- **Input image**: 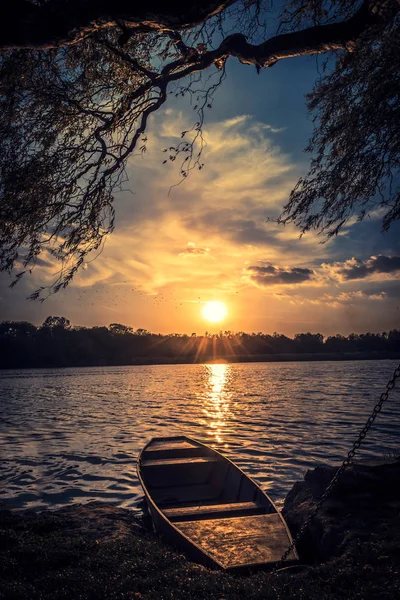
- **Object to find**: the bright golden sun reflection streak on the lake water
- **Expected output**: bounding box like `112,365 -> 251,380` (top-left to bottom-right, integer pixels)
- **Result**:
203,364 -> 231,446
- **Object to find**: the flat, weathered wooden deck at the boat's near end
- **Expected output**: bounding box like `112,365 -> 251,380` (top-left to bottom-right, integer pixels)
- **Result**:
174,513 -> 297,569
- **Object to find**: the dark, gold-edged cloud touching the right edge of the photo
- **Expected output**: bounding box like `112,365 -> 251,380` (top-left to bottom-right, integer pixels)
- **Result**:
321,254 -> 400,281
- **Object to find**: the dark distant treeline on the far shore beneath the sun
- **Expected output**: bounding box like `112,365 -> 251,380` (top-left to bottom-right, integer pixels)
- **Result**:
0,317 -> 400,368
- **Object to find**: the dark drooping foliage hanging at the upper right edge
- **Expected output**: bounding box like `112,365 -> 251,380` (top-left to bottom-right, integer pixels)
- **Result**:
281,7 -> 400,236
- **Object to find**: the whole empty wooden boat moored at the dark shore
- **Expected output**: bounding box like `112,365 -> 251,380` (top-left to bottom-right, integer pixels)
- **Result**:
137,436 -> 298,569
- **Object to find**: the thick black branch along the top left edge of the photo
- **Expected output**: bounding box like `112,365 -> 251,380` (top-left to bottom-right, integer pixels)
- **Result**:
0,0 -> 234,49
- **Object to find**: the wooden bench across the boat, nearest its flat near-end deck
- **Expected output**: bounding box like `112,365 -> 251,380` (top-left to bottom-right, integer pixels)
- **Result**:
163,502 -> 269,521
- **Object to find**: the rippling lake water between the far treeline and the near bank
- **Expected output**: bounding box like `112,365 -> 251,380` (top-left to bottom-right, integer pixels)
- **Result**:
0,360 -> 400,511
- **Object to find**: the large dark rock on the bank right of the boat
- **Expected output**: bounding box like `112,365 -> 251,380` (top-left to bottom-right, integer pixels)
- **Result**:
283,460 -> 400,563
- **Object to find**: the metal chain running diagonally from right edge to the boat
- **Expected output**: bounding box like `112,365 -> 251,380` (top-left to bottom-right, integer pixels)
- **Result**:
274,364 -> 400,572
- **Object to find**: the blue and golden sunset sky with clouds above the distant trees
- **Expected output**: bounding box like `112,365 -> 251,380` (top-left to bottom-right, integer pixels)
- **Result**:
0,52 -> 400,336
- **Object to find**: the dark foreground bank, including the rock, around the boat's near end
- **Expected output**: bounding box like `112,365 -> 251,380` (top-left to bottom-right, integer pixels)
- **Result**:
0,460 -> 400,600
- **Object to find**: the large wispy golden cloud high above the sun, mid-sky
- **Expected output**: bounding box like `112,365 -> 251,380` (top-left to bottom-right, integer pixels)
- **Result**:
113,109 -> 300,247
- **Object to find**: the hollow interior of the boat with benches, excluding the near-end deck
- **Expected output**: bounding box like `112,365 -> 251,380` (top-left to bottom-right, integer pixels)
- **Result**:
140,437 -> 276,521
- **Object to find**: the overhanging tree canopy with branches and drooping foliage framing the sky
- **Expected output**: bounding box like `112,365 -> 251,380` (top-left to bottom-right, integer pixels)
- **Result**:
0,0 -> 400,298
